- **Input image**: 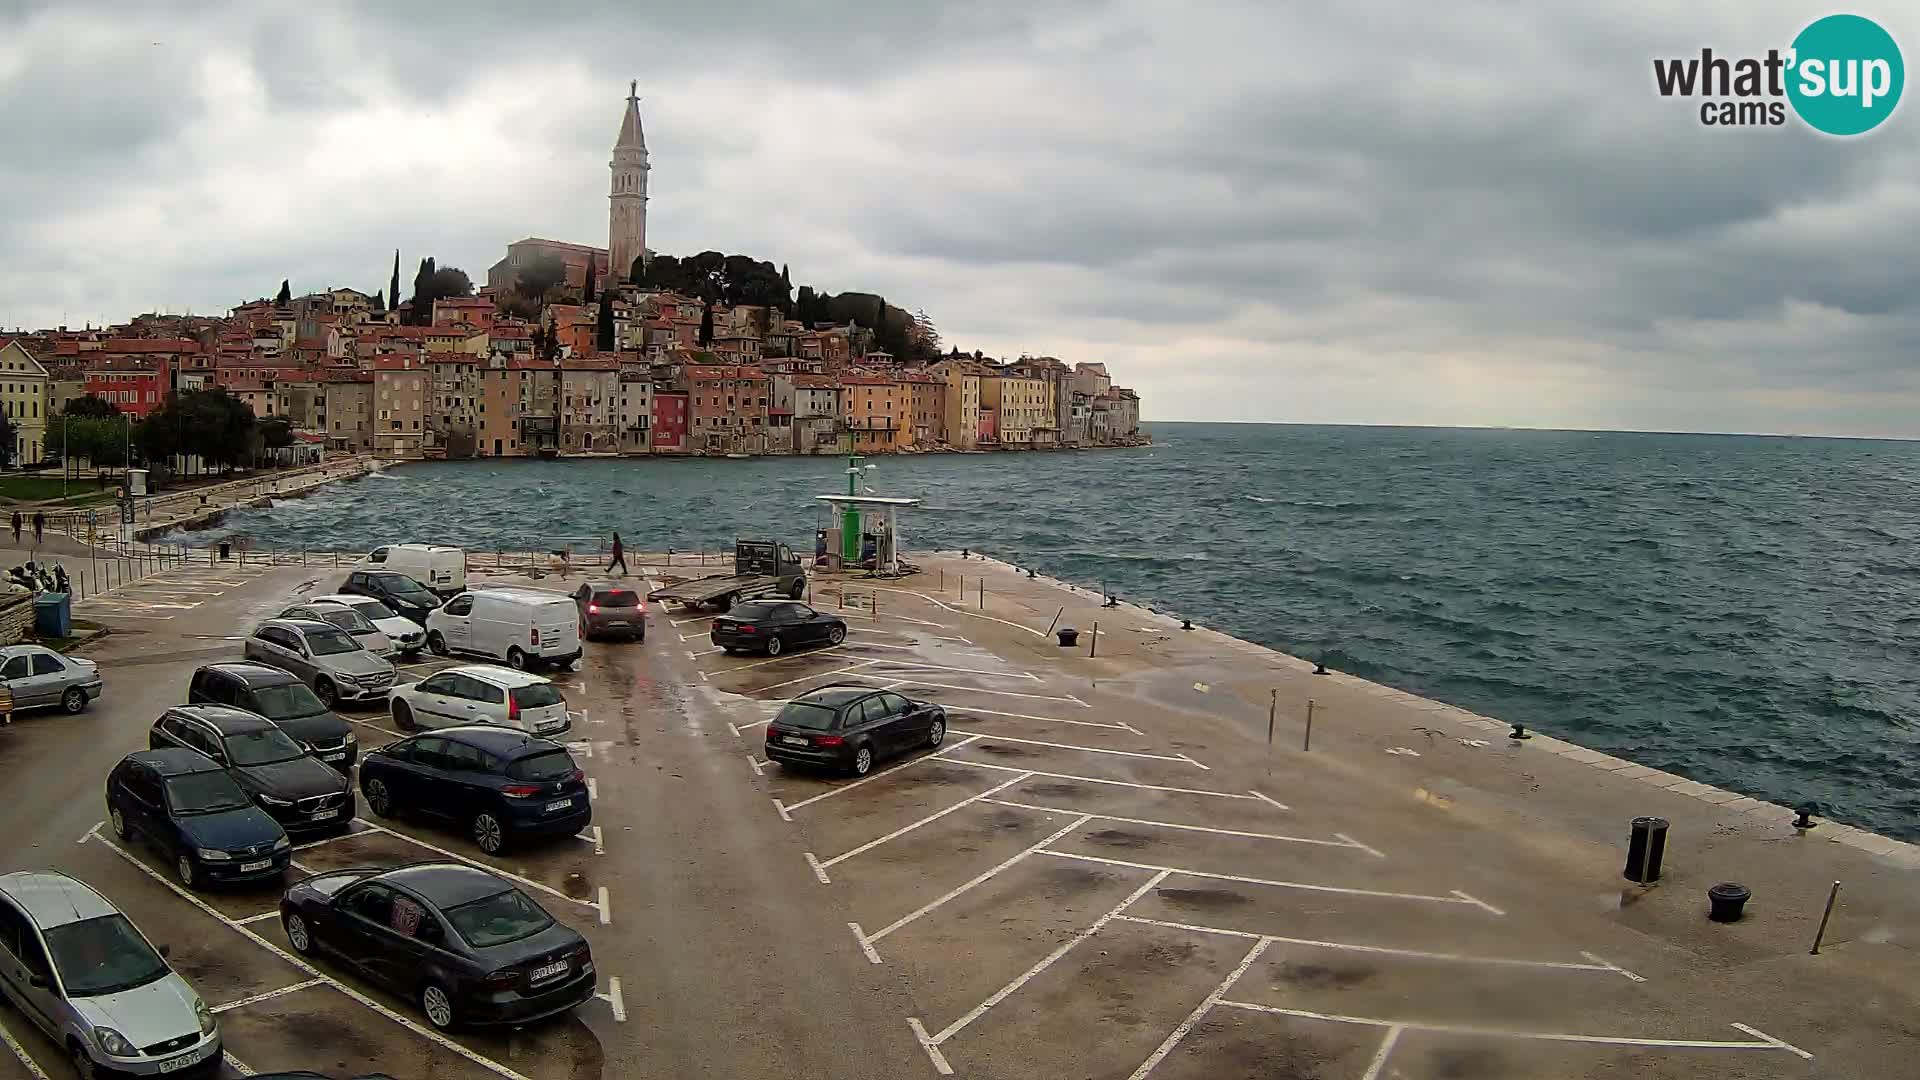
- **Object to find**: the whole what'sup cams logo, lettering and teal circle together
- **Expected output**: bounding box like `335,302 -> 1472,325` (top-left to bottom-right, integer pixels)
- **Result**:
1653,15 -> 1907,135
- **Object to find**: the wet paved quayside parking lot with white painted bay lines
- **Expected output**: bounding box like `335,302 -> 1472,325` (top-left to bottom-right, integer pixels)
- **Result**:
0,552 -> 1920,1080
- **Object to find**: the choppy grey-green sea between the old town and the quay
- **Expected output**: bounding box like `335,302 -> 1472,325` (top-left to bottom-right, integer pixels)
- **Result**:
188,423 -> 1920,840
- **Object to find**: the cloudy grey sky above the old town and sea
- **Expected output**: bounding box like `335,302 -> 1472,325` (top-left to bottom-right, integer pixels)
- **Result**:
0,0 -> 1920,438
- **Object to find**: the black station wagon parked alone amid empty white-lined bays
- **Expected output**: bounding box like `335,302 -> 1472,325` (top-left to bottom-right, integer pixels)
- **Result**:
766,684 -> 947,776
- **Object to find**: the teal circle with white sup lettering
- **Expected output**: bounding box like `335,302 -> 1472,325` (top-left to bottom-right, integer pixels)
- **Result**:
1788,15 -> 1907,135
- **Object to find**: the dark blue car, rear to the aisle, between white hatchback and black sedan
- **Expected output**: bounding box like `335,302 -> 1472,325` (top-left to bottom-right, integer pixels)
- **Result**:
361,724 -> 593,855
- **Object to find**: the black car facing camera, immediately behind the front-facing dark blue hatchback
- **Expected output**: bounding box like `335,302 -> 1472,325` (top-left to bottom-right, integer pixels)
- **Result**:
146,705 -> 355,836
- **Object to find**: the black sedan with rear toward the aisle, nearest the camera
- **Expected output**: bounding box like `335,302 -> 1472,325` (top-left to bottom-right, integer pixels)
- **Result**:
280,863 -> 595,1030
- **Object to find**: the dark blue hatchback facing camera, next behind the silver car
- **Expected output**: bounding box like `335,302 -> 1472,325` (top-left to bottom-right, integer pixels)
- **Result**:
108,746 -> 292,888
